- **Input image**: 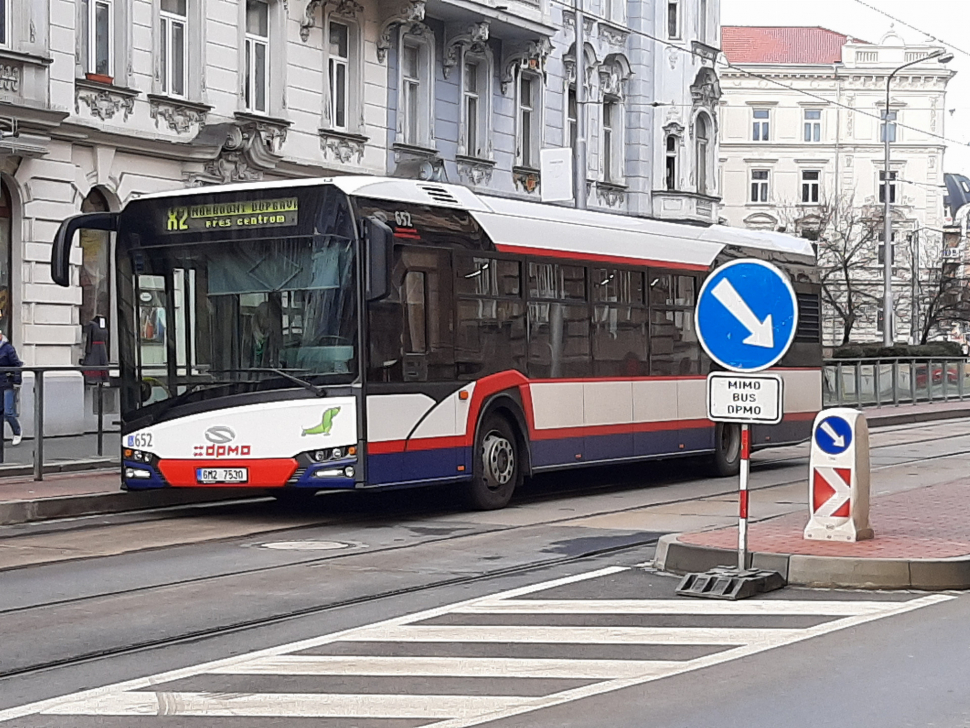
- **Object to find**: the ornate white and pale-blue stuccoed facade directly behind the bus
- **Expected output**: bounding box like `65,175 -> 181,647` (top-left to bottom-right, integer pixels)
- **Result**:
0,0 -> 720,434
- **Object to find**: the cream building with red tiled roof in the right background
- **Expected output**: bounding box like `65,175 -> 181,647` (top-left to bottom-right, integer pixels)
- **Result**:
720,27 -> 953,344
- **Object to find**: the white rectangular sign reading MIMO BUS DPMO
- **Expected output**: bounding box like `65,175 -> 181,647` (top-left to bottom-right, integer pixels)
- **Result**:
707,372 -> 785,425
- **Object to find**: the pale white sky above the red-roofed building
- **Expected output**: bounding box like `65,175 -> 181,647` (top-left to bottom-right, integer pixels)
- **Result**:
721,0 -> 970,176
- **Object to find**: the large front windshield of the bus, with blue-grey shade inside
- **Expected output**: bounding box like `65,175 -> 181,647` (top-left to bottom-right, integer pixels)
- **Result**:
118,188 -> 358,415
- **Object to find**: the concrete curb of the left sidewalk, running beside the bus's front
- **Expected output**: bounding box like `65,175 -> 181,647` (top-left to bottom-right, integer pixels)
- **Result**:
0,488 -> 266,526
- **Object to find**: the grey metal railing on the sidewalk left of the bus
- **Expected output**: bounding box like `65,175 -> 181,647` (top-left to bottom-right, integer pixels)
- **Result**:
0,364 -> 119,480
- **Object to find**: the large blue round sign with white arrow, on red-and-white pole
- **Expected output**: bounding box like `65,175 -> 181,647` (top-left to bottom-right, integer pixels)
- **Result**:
697,259 -> 798,372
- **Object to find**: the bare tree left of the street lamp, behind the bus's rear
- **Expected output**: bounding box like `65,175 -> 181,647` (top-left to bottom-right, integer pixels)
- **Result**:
778,195 -> 882,345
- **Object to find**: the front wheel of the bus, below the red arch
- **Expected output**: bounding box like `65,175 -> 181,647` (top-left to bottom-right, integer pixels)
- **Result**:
466,414 -> 522,511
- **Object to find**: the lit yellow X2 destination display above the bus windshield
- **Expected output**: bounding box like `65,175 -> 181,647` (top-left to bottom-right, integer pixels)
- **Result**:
165,197 -> 299,233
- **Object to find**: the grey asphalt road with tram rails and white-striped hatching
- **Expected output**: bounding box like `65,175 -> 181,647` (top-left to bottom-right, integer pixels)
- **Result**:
0,421 -> 970,728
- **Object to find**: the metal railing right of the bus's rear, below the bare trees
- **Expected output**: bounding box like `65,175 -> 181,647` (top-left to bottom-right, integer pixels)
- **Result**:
822,357 -> 970,407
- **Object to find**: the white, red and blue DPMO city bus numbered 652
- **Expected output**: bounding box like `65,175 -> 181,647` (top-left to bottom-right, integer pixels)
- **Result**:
51,176 -> 822,509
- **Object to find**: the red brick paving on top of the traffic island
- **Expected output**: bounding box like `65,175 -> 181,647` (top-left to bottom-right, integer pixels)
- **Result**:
679,478 -> 970,560
